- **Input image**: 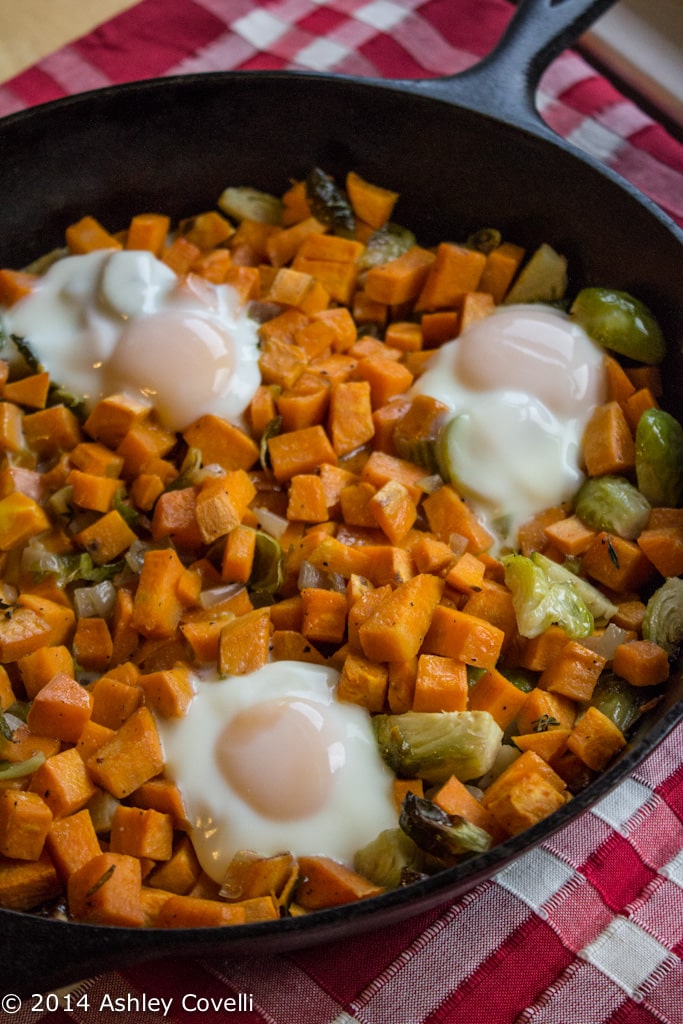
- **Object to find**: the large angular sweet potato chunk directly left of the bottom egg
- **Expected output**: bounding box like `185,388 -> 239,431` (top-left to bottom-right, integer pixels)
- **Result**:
86,706 -> 164,800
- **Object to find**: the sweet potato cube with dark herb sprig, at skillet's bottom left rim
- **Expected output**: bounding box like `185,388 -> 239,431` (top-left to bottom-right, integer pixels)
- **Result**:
67,852 -> 144,928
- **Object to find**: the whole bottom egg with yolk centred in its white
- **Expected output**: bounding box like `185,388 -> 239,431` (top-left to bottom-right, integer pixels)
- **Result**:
159,662 -> 397,882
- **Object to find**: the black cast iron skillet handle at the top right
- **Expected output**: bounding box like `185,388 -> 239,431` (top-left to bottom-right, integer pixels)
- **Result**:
413,0 -> 615,131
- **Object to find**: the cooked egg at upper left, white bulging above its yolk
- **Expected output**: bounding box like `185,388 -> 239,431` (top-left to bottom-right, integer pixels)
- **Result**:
5,250 -> 260,431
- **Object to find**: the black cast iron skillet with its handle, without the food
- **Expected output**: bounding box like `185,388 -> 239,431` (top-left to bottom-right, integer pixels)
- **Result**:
0,0 -> 683,994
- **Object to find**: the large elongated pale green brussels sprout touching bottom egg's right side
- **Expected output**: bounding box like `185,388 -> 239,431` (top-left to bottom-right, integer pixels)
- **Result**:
372,711 -> 503,782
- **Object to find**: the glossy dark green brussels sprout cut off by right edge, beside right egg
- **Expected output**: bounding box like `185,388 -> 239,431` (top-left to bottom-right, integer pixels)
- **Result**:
636,409 -> 683,508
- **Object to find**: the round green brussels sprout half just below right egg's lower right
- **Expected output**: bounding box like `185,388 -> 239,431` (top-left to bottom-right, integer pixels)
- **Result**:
574,475 -> 650,541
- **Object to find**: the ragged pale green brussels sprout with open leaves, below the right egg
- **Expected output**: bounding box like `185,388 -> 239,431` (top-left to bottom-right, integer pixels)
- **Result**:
503,555 -> 594,639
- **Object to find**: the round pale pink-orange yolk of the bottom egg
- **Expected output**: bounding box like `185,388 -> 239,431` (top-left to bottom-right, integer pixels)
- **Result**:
215,700 -> 343,820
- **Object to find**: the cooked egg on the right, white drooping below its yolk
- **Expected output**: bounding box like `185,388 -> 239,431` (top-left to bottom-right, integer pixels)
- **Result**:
414,304 -> 606,548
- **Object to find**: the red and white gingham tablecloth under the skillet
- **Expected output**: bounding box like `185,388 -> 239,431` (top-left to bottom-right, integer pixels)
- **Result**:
0,0 -> 683,1024
